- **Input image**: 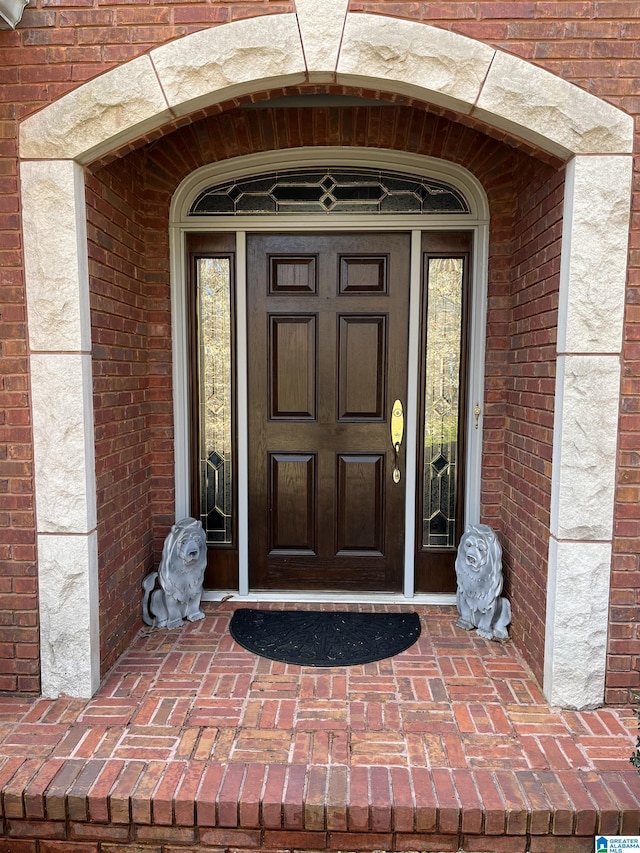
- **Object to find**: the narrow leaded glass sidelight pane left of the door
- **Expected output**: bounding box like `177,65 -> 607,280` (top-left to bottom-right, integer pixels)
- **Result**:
196,257 -> 233,545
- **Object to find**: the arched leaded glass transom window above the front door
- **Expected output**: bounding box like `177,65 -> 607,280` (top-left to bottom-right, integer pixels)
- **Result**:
189,169 -> 470,216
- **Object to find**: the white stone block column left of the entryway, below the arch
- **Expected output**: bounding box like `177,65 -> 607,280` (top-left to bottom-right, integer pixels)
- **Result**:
20,160 -> 100,697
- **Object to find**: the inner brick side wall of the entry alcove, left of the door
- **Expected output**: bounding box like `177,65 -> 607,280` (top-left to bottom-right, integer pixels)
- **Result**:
87,155 -> 152,673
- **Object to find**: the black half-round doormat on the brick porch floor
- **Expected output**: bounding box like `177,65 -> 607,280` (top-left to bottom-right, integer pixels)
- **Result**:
229,609 -> 420,666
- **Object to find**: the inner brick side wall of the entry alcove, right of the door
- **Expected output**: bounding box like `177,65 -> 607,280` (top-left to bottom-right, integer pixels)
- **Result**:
502,158 -> 564,680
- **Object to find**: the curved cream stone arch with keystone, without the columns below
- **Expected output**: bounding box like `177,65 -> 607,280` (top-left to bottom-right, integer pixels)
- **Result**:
20,0 -> 633,163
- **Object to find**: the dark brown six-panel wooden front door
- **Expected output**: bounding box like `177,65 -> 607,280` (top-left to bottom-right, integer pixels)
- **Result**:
247,234 -> 410,591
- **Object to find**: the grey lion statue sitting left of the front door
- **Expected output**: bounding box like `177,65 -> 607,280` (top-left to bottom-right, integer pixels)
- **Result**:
142,518 -> 207,628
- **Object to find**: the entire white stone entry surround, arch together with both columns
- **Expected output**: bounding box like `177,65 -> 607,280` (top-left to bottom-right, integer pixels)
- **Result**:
20,5 -> 633,707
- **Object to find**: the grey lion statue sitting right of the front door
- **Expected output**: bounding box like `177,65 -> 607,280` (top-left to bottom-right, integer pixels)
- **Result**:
455,524 -> 511,640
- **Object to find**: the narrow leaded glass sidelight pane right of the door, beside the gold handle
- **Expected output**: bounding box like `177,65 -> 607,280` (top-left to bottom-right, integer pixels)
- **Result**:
422,257 -> 464,548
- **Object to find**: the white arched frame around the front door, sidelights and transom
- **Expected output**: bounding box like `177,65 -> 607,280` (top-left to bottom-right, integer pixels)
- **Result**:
170,147 -> 489,604
